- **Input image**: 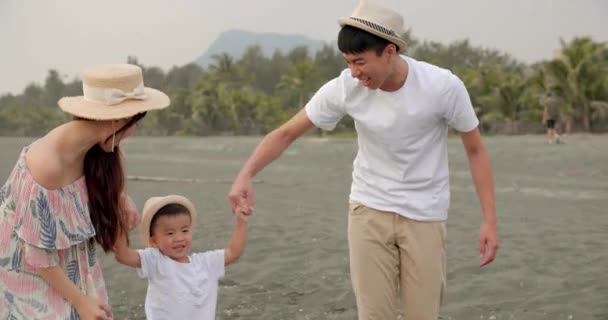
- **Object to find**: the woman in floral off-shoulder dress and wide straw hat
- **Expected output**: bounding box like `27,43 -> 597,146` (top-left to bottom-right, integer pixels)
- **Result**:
0,65 -> 169,320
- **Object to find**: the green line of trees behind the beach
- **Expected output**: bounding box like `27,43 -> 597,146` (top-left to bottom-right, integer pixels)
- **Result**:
0,33 -> 608,136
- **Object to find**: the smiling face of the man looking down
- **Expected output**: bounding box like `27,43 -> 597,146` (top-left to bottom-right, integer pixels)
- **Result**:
342,46 -> 392,90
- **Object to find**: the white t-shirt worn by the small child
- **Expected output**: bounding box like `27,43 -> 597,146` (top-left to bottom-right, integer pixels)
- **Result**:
137,248 -> 224,320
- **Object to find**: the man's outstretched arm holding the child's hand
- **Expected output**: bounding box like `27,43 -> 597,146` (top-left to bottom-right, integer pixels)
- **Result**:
228,109 -> 314,214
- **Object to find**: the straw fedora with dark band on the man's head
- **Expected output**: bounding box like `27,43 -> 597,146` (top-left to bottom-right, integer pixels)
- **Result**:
338,0 -> 407,52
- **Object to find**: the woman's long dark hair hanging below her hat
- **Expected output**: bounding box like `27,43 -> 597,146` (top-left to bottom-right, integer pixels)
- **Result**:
84,112 -> 146,252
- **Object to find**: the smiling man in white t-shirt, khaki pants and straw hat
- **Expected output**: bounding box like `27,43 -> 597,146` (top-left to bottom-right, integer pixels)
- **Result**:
229,2 -> 498,320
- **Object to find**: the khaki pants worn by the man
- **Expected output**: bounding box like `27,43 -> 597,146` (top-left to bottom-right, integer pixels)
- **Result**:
348,203 -> 446,320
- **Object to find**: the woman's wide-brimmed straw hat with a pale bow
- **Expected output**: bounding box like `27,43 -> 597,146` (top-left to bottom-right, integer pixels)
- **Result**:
59,64 -> 170,120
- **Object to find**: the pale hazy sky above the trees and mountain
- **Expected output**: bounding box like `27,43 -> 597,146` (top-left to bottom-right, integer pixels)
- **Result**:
0,0 -> 608,94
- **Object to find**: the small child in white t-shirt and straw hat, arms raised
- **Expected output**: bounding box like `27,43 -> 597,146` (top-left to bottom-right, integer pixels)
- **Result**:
114,195 -> 247,320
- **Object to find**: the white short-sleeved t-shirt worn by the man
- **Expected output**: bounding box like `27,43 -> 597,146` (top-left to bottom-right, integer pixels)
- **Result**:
305,56 -> 479,221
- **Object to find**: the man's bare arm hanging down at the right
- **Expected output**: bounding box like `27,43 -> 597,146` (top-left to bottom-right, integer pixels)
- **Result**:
460,129 -> 498,266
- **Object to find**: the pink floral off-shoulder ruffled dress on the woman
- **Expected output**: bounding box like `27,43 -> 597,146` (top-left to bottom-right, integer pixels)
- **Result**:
0,147 -> 108,320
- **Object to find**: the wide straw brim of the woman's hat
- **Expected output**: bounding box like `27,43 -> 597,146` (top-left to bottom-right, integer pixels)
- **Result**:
58,88 -> 171,120
